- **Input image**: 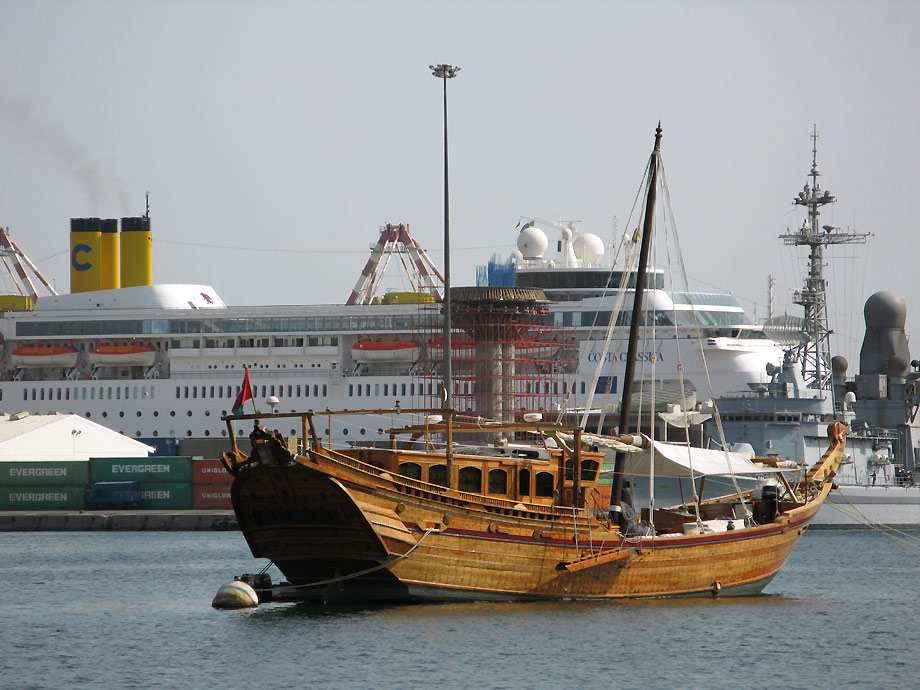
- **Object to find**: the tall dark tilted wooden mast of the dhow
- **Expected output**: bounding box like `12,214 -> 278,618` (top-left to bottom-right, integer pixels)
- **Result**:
610,122 -> 661,524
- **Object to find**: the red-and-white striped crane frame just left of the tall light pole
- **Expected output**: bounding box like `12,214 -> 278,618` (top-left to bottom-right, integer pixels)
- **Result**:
345,223 -> 444,306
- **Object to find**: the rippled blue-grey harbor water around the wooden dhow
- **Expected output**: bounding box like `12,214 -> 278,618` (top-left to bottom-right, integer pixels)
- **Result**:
0,531 -> 920,689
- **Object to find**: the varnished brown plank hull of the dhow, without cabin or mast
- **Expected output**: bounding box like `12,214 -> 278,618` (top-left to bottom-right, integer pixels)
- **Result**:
233,436 -> 842,601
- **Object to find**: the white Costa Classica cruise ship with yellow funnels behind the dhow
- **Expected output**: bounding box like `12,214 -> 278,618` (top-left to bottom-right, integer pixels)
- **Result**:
0,214 -> 783,456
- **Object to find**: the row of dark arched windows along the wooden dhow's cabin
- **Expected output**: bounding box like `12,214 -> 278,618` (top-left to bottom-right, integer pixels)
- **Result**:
399,460 -> 599,498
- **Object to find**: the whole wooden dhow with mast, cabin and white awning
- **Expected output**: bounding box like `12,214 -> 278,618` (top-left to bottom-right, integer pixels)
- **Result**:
223,127 -> 845,602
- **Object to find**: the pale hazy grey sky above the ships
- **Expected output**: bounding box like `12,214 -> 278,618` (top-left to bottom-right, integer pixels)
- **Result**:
0,0 -> 920,366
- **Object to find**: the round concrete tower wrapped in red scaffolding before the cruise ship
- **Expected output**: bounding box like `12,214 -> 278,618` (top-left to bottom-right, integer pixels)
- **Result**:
417,287 -> 575,422
